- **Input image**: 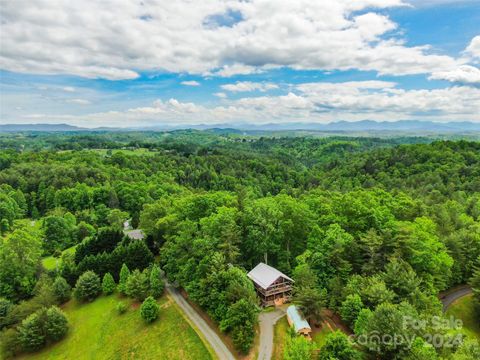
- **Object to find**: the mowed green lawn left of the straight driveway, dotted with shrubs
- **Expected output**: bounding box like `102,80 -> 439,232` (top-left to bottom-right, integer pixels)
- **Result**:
19,295 -> 212,360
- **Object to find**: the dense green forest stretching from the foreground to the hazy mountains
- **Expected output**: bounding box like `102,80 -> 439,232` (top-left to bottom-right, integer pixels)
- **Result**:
0,130 -> 480,360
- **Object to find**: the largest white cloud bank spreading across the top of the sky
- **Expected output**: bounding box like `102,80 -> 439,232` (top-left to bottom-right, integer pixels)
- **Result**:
0,0 -> 466,80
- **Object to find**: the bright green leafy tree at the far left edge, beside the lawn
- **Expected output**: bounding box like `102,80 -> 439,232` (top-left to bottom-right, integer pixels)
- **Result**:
0,229 -> 42,301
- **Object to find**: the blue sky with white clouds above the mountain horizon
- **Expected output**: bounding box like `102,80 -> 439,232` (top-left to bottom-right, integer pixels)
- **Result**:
0,0 -> 480,127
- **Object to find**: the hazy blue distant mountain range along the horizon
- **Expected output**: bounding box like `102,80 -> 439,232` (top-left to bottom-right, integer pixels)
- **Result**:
0,120 -> 480,133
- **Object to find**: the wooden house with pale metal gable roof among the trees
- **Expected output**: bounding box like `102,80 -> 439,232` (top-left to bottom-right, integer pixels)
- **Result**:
247,263 -> 294,306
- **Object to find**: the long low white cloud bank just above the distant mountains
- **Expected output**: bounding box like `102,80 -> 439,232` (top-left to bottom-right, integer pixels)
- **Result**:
11,81 -> 480,126
